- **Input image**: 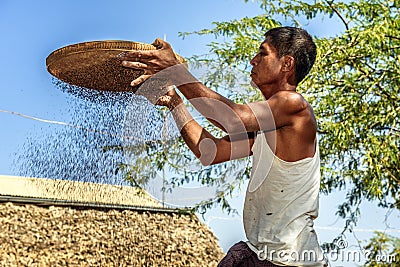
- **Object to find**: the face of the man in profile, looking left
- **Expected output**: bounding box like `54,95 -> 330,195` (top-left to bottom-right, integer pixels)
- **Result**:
250,38 -> 283,90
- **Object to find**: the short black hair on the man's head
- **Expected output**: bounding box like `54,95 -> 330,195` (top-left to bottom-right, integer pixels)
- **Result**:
265,26 -> 317,84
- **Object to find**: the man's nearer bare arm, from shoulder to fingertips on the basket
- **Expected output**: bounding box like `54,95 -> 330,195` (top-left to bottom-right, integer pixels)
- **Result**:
123,39 -> 306,135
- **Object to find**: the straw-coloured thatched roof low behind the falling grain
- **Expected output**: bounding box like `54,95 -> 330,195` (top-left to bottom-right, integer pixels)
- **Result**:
0,176 -> 223,266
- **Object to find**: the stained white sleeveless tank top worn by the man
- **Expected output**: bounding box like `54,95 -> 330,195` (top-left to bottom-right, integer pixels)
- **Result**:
243,132 -> 326,266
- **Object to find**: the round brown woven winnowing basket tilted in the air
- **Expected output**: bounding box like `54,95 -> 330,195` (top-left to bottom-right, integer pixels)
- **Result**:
46,40 -> 184,92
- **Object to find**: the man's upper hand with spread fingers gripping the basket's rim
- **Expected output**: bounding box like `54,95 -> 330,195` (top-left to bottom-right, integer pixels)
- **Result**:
122,38 -> 180,86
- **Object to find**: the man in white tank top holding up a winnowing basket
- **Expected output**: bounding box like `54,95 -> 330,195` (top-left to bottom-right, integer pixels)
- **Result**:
123,27 -> 326,266
